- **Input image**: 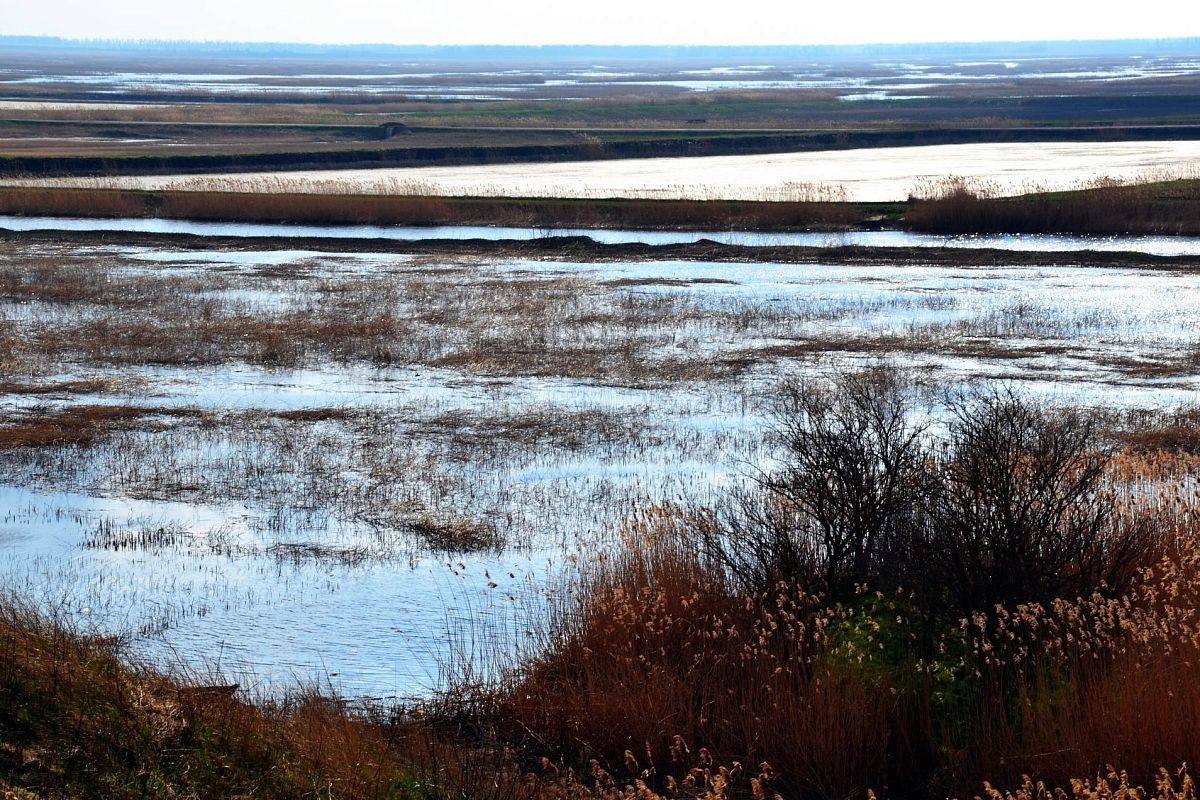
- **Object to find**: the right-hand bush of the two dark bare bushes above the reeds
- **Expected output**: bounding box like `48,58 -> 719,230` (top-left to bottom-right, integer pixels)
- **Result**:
910,391 -> 1138,613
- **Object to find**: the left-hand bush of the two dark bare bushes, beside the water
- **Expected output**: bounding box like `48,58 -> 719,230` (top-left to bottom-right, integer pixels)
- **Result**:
706,367 -> 925,590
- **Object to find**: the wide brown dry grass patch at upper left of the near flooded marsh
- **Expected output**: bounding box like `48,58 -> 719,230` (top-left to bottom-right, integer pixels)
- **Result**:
6,248 -> 768,384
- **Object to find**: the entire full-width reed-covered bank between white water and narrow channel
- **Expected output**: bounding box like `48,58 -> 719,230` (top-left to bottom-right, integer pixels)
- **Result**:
0,178 -> 1200,235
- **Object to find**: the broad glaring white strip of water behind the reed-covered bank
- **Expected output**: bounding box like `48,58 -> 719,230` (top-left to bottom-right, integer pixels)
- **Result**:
5,142 -> 1200,203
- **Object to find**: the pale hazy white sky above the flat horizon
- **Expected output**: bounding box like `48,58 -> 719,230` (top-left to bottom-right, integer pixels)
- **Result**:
0,0 -> 1200,44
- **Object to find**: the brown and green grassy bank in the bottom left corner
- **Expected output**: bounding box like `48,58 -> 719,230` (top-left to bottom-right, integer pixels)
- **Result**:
0,599 -> 427,799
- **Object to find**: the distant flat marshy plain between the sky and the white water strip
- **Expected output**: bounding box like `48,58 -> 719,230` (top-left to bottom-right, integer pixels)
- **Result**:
0,37 -> 1200,175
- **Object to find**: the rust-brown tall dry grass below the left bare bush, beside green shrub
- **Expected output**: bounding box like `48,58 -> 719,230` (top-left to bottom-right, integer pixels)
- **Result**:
496,505 -> 914,798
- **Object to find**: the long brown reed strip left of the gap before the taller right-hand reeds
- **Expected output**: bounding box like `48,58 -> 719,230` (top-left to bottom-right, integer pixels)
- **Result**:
0,183 -> 866,230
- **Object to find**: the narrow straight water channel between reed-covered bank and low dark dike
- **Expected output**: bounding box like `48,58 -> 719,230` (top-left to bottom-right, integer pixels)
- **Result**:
7,216 -> 1200,255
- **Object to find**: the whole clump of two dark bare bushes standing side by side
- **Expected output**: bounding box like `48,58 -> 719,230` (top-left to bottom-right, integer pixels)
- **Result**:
695,367 -> 1159,614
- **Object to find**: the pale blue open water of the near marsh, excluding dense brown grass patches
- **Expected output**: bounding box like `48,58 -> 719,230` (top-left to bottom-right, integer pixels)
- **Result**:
0,245 -> 1200,698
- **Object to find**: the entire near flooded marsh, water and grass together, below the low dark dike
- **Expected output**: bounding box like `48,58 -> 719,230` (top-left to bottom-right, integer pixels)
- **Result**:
0,235 -> 1200,699
